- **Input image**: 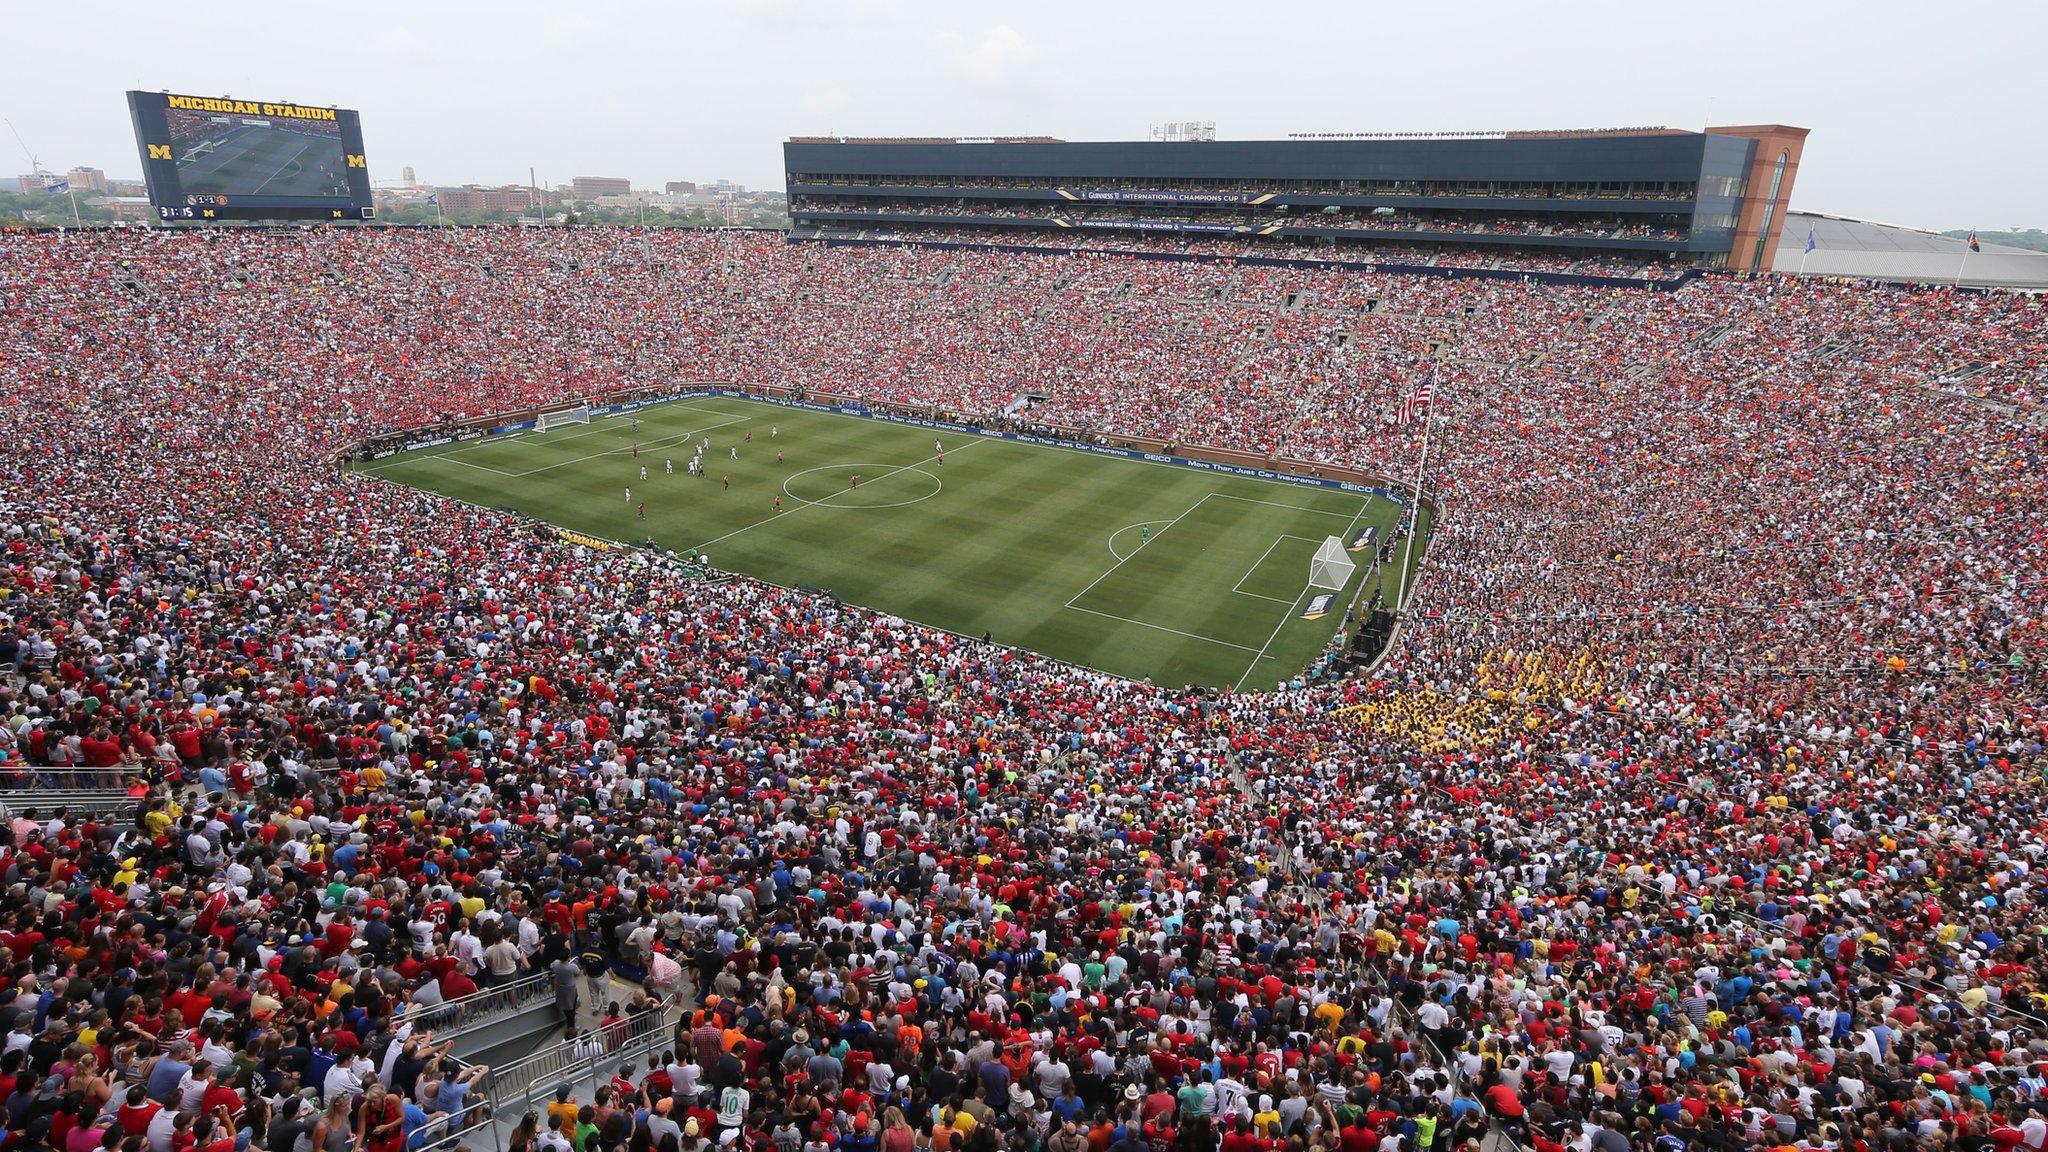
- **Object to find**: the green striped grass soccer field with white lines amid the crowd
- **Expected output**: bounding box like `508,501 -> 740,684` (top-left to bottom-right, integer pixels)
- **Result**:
362,398 -> 1427,689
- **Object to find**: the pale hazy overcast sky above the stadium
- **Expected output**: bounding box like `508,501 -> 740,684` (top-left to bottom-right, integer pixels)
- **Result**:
0,0 -> 2048,230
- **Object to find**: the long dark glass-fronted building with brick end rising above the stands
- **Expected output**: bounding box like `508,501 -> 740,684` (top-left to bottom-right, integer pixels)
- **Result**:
782,125 -> 1806,273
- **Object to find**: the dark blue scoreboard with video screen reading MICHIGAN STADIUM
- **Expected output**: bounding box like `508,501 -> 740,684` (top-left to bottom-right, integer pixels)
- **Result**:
129,92 -> 375,221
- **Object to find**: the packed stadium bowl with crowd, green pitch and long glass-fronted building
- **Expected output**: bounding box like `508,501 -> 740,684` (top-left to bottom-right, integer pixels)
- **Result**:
0,73 -> 2048,1152
